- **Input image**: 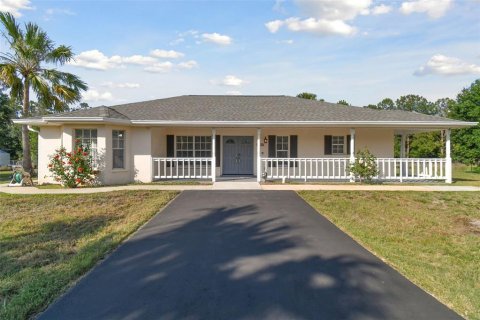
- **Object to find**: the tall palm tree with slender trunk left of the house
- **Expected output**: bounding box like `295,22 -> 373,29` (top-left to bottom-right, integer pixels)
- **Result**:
0,13 -> 87,172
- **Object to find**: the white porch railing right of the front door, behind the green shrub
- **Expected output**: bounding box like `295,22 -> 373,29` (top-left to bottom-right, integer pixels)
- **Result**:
260,158 -> 446,182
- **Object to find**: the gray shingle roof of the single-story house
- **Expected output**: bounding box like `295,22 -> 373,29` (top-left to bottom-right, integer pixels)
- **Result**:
42,95 -> 468,122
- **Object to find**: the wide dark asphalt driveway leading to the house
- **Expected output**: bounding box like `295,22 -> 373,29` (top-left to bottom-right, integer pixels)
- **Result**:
40,191 -> 460,320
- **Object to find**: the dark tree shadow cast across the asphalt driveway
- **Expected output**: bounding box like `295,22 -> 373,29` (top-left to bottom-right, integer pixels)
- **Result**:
41,205 -> 394,319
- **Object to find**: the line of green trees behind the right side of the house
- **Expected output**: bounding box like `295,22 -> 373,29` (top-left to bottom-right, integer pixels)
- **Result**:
297,79 -> 480,165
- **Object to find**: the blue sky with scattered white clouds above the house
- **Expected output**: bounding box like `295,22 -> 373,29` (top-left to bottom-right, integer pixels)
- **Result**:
0,0 -> 480,106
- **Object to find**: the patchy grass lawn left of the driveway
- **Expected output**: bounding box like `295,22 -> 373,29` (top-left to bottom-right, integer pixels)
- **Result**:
0,191 -> 176,320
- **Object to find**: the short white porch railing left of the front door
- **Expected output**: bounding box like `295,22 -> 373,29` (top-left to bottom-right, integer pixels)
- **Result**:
152,157 -> 215,180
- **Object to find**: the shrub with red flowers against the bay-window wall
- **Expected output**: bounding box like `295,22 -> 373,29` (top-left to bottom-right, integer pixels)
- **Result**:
48,144 -> 95,188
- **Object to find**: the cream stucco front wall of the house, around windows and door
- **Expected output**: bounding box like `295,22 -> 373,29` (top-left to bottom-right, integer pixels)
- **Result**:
38,125 -> 394,185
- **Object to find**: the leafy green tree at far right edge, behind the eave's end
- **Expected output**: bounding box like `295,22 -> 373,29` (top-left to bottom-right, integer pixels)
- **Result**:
448,79 -> 480,164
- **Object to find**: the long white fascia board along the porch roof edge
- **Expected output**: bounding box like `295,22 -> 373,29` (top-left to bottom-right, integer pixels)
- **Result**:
131,120 -> 478,129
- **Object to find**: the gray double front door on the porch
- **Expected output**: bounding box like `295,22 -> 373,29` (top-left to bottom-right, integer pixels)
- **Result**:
223,136 -> 253,175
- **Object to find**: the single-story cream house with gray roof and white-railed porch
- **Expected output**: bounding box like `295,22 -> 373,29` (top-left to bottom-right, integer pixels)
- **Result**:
14,95 -> 476,184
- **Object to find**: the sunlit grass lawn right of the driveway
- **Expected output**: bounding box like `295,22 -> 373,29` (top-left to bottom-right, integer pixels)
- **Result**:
299,191 -> 480,319
